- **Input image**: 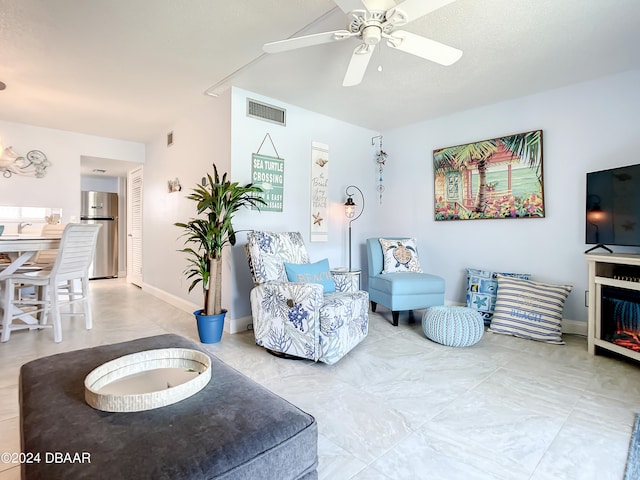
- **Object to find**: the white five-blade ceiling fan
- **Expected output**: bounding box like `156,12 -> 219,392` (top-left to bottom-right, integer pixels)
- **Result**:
262,0 -> 462,87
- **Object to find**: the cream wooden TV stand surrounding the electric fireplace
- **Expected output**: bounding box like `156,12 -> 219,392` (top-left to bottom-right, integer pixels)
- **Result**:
585,253 -> 640,361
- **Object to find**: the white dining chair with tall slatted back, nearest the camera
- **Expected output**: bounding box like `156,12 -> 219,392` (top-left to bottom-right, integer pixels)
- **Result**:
0,223 -> 101,343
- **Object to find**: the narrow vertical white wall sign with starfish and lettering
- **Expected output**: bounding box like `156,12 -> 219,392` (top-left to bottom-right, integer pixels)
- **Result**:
311,142 -> 329,242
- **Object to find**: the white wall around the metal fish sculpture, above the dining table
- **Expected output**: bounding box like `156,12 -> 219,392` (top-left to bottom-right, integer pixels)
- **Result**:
0,121 -> 145,233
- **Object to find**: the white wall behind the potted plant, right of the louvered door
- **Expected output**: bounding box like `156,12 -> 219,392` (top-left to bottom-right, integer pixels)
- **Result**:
142,92 -> 231,316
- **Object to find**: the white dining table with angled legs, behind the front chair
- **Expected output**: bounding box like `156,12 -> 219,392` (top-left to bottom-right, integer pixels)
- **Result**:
0,234 -> 61,328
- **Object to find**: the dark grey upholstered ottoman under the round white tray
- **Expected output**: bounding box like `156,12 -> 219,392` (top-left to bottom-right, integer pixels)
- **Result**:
20,335 -> 318,480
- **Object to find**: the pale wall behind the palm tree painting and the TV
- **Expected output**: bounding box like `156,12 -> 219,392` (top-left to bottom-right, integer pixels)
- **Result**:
380,70 -> 640,322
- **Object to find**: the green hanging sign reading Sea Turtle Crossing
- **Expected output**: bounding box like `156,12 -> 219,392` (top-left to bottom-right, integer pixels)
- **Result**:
251,133 -> 284,212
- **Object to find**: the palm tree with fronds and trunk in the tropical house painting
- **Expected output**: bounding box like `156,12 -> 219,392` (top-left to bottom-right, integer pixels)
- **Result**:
434,130 -> 542,213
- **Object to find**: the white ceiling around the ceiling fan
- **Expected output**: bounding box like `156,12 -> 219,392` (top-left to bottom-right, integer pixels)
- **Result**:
0,0 -> 640,148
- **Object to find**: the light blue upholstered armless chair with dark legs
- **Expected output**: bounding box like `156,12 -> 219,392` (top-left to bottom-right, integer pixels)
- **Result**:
367,237 -> 444,326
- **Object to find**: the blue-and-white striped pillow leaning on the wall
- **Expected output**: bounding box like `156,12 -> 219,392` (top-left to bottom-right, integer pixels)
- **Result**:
489,275 -> 573,345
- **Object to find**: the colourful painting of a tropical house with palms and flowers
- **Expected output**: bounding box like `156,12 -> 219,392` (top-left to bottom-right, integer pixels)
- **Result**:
433,130 -> 544,220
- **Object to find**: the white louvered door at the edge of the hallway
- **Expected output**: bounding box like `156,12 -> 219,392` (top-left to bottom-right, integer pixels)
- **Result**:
127,167 -> 142,287
